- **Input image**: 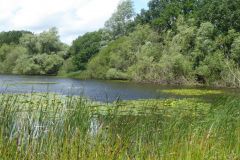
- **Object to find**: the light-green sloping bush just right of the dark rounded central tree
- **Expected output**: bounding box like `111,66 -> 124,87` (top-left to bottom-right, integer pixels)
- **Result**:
87,25 -> 159,79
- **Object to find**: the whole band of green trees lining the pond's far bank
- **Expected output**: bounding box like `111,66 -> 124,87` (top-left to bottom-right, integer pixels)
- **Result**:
0,0 -> 240,87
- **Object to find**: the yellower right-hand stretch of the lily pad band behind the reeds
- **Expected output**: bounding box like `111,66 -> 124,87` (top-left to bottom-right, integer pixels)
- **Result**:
93,98 -> 211,115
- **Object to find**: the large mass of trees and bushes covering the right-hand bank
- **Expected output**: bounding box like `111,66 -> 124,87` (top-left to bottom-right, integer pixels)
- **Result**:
70,0 -> 240,87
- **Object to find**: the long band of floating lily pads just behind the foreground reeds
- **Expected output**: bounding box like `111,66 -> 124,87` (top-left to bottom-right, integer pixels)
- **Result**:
0,93 -> 211,115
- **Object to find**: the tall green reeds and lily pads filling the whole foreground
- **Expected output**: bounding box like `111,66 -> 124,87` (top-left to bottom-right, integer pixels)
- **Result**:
0,94 -> 240,160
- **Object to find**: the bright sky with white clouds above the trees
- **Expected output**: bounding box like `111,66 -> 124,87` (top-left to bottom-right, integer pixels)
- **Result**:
0,0 -> 149,44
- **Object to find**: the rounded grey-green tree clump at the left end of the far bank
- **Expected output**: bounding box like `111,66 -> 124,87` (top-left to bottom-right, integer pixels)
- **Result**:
0,28 -> 68,75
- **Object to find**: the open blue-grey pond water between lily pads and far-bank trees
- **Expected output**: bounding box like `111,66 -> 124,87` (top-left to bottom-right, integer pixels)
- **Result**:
0,75 -> 232,102
